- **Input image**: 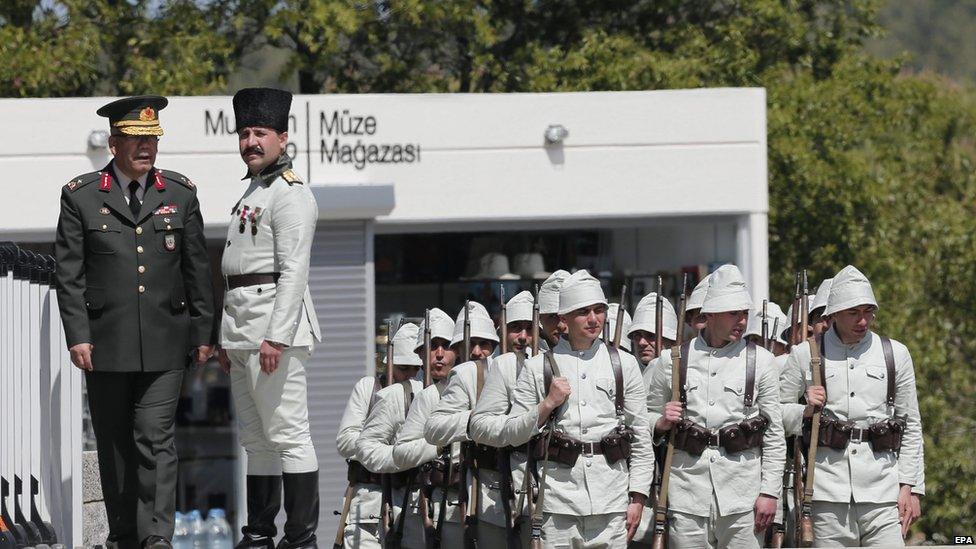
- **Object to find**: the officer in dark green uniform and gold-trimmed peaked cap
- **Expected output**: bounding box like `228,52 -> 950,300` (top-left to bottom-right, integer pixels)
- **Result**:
55,96 -> 215,549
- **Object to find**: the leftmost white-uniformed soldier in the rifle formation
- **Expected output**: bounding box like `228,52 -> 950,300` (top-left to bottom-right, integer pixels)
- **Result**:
336,323 -> 423,549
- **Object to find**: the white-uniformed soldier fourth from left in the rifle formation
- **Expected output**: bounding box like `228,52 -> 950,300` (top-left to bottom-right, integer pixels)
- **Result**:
426,292 -> 533,547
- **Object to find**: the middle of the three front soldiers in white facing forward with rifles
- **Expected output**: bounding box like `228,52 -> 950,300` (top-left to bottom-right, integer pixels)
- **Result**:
645,265 -> 786,549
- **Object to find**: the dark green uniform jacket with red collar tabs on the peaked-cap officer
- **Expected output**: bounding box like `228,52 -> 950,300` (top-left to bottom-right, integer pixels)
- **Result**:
54,163 -> 215,372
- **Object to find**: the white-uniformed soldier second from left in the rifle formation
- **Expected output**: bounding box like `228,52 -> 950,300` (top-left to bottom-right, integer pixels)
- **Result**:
356,309 -> 456,549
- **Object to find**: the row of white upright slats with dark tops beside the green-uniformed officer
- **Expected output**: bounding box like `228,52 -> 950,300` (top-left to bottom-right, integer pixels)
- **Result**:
0,242 -> 83,547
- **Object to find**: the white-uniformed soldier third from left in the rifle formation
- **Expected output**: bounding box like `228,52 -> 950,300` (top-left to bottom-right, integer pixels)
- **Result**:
393,301 -> 498,547
